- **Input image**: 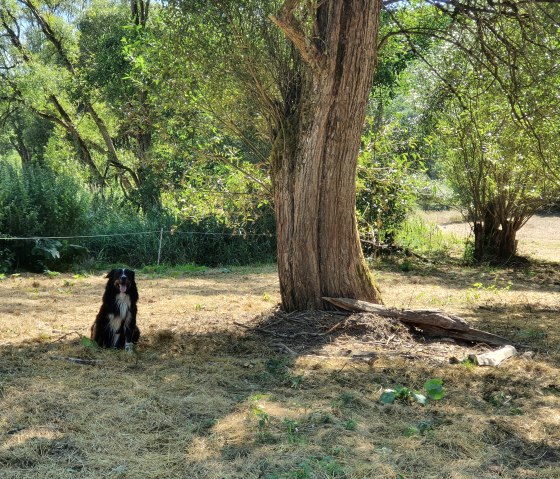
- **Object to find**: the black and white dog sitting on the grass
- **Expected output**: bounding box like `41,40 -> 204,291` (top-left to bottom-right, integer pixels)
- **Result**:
91,269 -> 140,351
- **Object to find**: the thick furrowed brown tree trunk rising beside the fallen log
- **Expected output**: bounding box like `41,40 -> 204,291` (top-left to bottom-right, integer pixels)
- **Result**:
272,0 -> 381,311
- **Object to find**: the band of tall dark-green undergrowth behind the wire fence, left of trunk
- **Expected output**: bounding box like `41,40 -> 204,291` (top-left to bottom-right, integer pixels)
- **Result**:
0,162 -> 276,272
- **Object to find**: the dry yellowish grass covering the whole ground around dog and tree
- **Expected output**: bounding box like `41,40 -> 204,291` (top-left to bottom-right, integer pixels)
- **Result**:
0,251 -> 560,479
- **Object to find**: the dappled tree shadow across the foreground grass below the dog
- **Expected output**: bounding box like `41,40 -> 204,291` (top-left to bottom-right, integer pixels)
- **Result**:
0,315 -> 560,479
